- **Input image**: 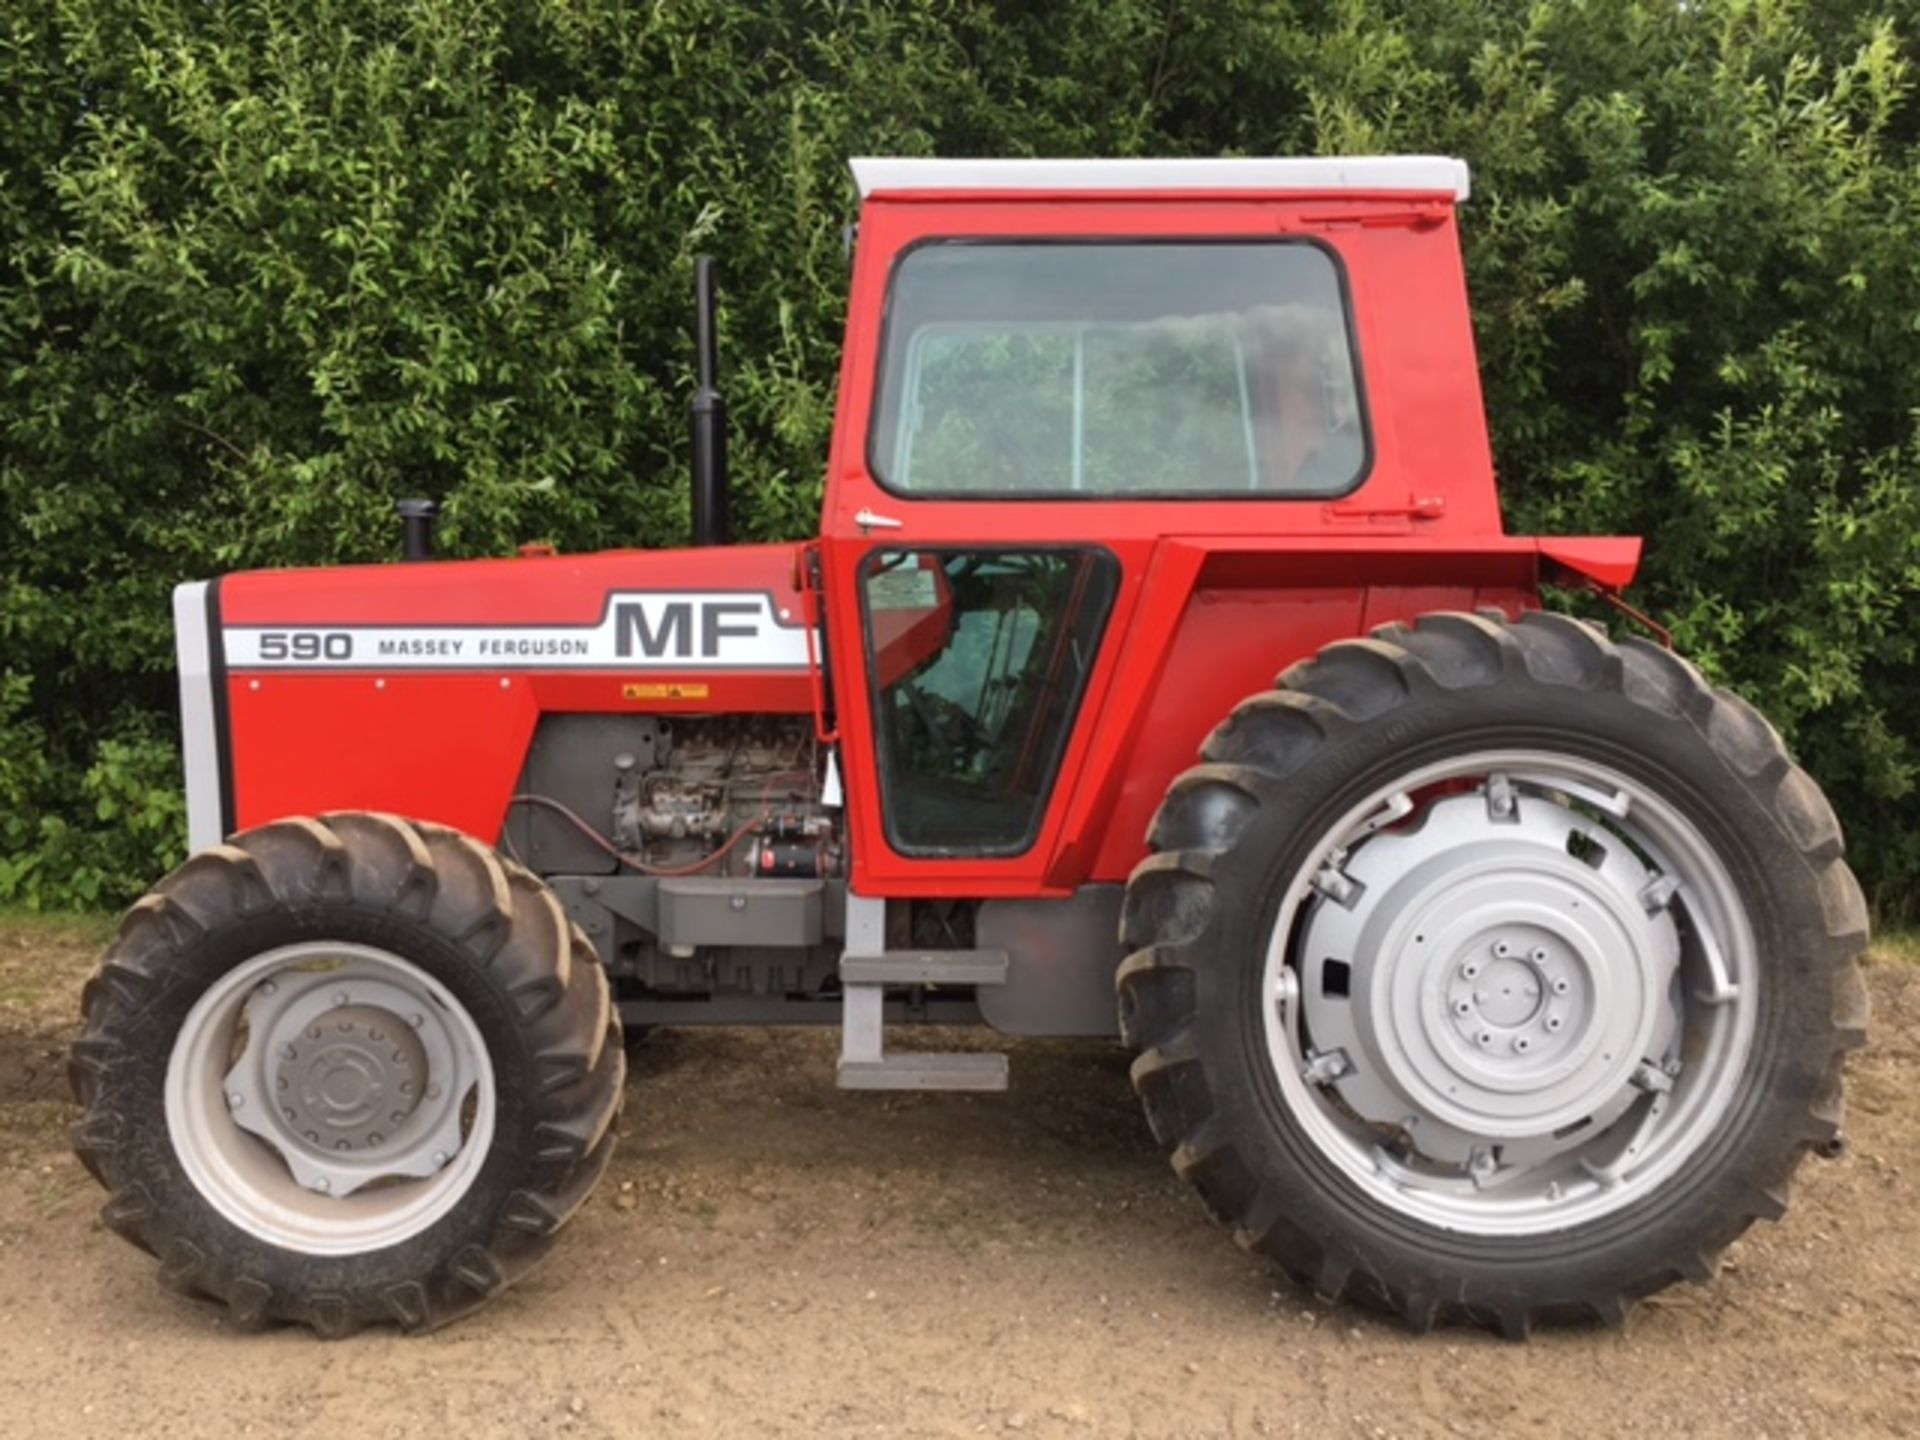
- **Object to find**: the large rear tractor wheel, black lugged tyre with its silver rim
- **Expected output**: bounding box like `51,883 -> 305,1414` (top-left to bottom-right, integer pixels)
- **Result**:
1117,614 -> 1866,1336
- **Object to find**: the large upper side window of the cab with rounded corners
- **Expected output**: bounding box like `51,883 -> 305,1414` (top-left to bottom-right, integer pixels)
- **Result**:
870,242 -> 1369,497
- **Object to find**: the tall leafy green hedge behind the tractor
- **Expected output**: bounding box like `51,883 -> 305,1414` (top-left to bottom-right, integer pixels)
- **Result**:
0,0 -> 1920,910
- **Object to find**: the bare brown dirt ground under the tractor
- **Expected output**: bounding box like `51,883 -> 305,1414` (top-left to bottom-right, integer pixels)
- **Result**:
0,922 -> 1920,1440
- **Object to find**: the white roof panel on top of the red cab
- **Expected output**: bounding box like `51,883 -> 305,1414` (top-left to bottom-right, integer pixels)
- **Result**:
852,156 -> 1467,200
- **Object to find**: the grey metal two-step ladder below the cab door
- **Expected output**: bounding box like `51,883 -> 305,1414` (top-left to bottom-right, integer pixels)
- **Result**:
839,895 -> 1008,1091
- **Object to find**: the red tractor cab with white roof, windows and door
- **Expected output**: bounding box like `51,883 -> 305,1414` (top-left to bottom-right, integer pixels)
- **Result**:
822,157 -> 1582,895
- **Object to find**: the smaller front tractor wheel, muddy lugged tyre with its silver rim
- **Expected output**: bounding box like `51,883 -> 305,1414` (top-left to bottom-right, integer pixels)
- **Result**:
69,812 -> 626,1336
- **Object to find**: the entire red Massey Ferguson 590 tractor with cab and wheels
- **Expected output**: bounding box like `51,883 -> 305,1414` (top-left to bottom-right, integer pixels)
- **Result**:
71,157 -> 1866,1336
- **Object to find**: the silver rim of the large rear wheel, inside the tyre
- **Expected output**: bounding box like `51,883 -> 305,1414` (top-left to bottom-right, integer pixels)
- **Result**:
1261,749 -> 1759,1235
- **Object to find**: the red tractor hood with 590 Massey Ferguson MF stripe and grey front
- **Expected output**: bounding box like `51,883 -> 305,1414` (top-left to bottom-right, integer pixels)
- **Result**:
175,545 -> 812,849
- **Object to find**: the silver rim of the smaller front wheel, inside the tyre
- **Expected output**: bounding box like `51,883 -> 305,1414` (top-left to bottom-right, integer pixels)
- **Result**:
165,941 -> 495,1256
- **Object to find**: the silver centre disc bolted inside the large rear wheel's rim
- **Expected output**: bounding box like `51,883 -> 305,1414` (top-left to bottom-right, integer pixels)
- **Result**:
1302,793 -> 1680,1165
